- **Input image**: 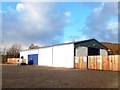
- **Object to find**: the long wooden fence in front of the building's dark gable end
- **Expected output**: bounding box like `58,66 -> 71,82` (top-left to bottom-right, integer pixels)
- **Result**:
74,55 -> 120,71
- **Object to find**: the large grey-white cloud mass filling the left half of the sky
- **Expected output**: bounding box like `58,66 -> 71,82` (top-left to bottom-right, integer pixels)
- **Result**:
2,2 -> 66,47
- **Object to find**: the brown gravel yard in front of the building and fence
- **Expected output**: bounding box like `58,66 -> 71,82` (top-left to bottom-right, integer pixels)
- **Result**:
2,65 -> 118,88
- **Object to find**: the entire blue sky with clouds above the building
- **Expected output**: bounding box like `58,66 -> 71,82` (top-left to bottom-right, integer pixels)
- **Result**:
0,0 -> 118,49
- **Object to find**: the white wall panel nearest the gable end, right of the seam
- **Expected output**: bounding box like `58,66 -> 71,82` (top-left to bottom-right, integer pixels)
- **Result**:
53,44 -> 74,68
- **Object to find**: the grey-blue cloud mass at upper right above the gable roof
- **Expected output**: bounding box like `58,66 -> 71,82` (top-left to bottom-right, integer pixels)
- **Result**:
85,2 -> 118,42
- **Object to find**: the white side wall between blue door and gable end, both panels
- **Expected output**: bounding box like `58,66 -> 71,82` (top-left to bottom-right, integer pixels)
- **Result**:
38,44 -> 74,68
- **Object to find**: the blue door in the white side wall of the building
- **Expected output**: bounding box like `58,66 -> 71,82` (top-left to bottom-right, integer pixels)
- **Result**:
28,54 -> 38,65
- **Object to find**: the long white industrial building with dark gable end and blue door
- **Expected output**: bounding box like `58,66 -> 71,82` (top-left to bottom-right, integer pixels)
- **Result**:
20,39 -> 108,68
